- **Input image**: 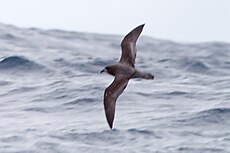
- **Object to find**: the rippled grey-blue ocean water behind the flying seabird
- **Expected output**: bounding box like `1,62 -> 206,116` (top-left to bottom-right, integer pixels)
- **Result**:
0,24 -> 230,153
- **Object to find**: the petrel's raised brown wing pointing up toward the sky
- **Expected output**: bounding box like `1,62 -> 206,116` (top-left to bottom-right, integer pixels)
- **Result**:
119,24 -> 144,67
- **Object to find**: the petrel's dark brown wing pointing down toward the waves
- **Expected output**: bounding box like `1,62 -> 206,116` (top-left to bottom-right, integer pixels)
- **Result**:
104,75 -> 129,129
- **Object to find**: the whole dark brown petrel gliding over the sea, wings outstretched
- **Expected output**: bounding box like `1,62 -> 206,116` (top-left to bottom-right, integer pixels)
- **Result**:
101,24 -> 154,129
